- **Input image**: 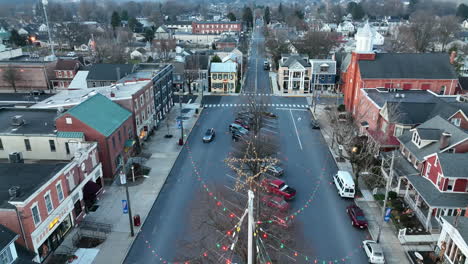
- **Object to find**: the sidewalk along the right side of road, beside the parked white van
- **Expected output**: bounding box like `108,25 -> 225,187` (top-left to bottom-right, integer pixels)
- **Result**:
307,103 -> 410,264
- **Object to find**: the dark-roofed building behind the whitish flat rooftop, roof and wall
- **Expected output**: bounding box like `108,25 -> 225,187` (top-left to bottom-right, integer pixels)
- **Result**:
86,63 -> 135,87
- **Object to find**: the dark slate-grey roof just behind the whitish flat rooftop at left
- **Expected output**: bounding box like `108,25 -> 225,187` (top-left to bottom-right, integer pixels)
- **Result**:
86,63 -> 134,81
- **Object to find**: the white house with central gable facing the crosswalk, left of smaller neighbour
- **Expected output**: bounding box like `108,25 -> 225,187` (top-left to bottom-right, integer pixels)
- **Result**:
278,54 -> 311,93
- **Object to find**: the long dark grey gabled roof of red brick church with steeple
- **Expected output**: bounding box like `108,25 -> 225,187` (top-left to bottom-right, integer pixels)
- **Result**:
358,53 -> 458,80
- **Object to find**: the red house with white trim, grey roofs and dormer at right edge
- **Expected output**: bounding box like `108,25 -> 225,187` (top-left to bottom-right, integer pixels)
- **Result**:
382,115 -> 468,233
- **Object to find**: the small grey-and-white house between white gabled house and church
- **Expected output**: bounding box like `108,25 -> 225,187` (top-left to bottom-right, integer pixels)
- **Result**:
309,59 -> 336,91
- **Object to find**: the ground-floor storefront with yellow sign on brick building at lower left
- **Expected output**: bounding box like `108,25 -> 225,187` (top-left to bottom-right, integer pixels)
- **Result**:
38,214 -> 72,262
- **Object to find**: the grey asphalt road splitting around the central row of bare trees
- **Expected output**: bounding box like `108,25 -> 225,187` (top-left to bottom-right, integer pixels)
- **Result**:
124,25 -> 368,264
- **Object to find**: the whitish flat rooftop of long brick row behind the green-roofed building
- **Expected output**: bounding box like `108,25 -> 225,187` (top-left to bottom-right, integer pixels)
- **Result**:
33,80 -> 151,108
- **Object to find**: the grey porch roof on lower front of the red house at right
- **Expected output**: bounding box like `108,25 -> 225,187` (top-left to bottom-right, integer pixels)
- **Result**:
406,175 -> 468,208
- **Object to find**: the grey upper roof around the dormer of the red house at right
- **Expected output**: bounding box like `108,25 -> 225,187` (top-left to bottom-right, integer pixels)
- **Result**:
398,116 -> 468,161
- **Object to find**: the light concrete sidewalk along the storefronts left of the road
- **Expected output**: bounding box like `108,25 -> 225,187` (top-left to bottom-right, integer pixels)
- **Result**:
55,100 -> 201,264
